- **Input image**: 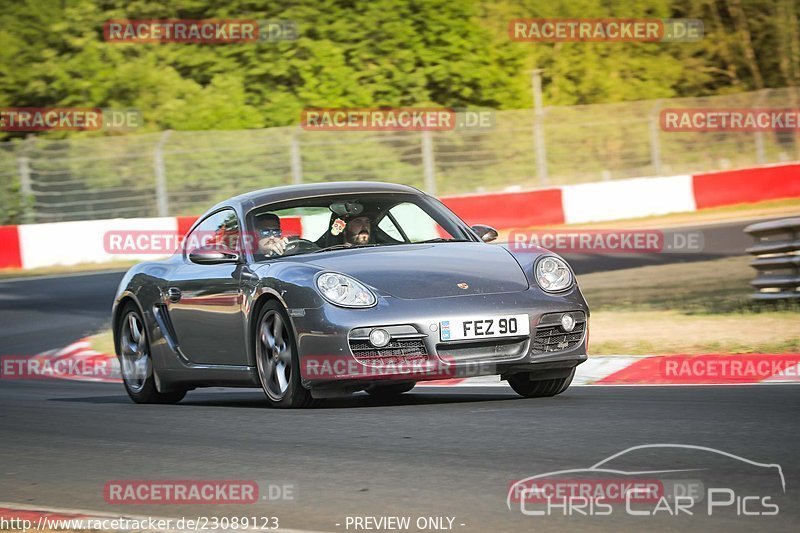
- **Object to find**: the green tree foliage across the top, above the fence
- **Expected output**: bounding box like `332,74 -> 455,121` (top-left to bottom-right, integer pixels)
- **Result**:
0,0 -> 800,131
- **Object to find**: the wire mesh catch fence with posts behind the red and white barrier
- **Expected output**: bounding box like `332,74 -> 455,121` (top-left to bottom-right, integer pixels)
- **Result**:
0,87 -> 800,224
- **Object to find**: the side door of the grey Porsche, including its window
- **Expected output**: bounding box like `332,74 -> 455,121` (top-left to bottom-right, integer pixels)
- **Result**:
167,209 -> 247,365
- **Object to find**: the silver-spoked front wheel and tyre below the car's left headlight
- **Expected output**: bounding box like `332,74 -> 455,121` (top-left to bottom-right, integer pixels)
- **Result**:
254,300 -> 317,409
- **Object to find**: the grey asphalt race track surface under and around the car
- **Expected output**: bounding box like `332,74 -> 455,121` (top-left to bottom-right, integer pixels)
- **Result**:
0,214 -> 800,531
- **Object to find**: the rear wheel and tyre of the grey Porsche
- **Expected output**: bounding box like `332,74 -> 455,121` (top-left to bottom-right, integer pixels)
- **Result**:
115,303 -> 186,404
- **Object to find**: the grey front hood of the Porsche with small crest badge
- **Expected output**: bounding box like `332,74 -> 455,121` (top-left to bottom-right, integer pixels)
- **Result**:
302,242 -> 528,300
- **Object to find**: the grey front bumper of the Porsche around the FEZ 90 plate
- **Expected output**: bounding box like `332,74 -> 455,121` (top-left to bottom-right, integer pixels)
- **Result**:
289,286 -> 589,393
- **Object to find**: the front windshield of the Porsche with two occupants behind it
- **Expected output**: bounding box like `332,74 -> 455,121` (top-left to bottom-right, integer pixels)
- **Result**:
247,193 -> 476,261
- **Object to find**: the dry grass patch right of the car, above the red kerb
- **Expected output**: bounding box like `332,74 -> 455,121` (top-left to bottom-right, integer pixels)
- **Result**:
578,257 -> 800,355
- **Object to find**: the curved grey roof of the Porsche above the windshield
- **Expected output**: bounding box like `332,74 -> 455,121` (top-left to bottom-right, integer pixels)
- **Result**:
209,181 -> 424,212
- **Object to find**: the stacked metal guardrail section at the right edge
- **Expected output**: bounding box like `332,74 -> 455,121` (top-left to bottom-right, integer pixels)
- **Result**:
744,217 -> 800,300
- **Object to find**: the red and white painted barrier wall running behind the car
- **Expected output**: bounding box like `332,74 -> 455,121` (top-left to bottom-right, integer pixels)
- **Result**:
0,162 -> 800,269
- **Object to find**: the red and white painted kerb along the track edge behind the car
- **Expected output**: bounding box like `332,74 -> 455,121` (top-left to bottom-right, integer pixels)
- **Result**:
9,339 -> 800,387
